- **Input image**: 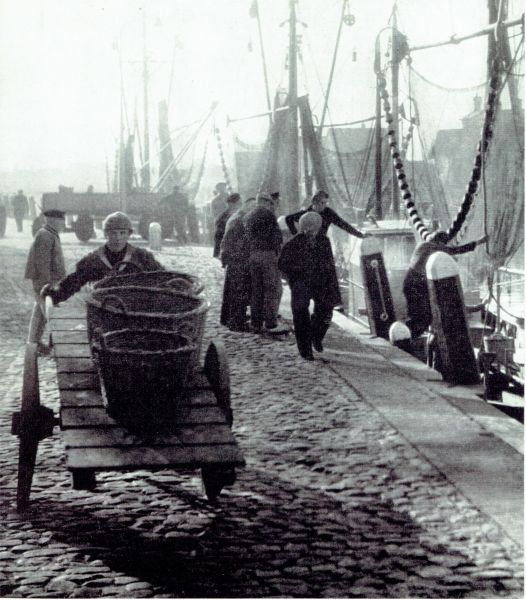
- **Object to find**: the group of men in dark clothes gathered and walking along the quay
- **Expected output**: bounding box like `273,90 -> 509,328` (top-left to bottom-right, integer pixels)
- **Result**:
214,192 -> 354,361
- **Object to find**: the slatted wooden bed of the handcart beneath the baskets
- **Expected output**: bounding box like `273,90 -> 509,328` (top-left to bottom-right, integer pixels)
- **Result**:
50,306 -> 245,487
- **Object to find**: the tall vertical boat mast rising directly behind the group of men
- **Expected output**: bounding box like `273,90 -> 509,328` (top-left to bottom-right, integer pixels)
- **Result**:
286,0 -> 299,213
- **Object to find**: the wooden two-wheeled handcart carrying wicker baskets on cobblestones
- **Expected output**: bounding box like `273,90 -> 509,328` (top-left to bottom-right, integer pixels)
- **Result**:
12,305 -> 245,510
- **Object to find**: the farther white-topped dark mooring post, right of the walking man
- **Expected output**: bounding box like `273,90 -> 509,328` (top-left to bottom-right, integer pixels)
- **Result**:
360,237 -> 395,340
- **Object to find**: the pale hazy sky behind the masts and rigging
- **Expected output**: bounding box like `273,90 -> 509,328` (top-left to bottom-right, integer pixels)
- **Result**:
0,0 -> 521,188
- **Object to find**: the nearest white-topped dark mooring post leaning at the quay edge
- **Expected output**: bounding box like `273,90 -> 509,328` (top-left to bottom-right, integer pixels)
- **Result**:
426,252 -> 480,385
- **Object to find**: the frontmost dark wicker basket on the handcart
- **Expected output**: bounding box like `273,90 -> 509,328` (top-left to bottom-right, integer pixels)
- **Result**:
91,329 -> 196,418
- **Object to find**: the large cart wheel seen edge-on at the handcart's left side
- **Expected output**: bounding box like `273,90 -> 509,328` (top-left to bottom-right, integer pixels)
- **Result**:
16,344 -> 40,510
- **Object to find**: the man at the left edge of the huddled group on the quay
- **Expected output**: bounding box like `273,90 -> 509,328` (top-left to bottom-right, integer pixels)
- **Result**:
220,198 -> 256,331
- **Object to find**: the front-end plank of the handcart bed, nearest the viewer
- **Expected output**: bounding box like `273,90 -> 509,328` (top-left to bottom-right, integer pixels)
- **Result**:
66,444 -> 245,470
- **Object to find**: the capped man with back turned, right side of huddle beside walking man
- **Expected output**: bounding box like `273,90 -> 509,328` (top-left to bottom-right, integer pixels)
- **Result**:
245,194 -> 288,333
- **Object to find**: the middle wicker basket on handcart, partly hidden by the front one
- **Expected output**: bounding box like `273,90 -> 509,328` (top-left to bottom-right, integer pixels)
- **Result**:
86,286 -> 209,368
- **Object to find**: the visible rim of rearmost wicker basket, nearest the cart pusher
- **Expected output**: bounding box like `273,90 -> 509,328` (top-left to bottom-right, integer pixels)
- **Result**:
93,271 -> 204,296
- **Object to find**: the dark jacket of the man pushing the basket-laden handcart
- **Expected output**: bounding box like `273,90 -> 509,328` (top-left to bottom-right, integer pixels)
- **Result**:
50,244 -> 164,303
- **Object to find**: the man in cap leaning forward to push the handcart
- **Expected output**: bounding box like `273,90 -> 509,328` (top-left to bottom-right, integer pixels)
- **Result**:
41,212 -> 164,304
